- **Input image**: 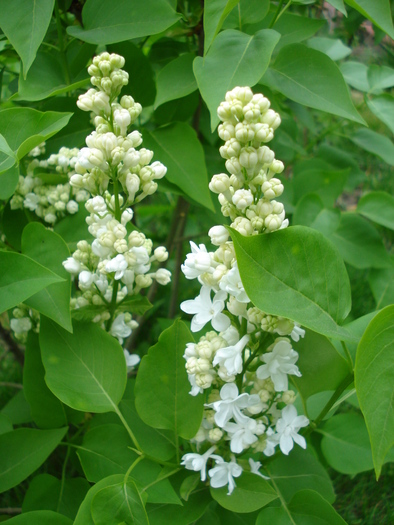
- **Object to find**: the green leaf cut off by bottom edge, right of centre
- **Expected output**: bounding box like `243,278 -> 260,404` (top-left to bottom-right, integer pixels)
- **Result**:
256,490 -> 346,525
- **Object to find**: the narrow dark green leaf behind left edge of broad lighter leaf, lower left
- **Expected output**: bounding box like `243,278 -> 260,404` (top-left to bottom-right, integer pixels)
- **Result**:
23,332 -> 67,428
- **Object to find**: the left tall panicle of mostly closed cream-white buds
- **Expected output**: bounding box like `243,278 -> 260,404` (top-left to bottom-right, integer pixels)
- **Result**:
63,52 -> 171,360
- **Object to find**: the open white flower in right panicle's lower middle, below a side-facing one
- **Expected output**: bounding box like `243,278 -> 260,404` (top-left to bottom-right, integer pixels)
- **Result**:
205,383 -> 260,428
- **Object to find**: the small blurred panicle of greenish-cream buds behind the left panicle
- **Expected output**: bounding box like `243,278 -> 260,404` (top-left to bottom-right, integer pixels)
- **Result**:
10,143 -> 89,225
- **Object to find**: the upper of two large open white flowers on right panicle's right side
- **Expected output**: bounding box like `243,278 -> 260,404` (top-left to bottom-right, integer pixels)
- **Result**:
256,339 -> 301,392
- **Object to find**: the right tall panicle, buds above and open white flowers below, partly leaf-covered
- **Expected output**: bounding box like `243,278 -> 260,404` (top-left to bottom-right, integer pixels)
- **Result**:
181,87 -> 309,494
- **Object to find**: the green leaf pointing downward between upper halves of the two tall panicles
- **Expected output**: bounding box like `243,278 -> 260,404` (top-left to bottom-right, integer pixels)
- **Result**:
143,122 -> 213,211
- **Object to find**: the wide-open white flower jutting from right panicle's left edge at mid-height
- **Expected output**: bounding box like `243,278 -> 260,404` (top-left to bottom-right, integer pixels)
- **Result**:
181,286 -> 231,332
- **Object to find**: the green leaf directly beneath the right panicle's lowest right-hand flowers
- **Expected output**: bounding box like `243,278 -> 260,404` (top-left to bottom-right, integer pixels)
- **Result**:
265,446 -> 335,503
